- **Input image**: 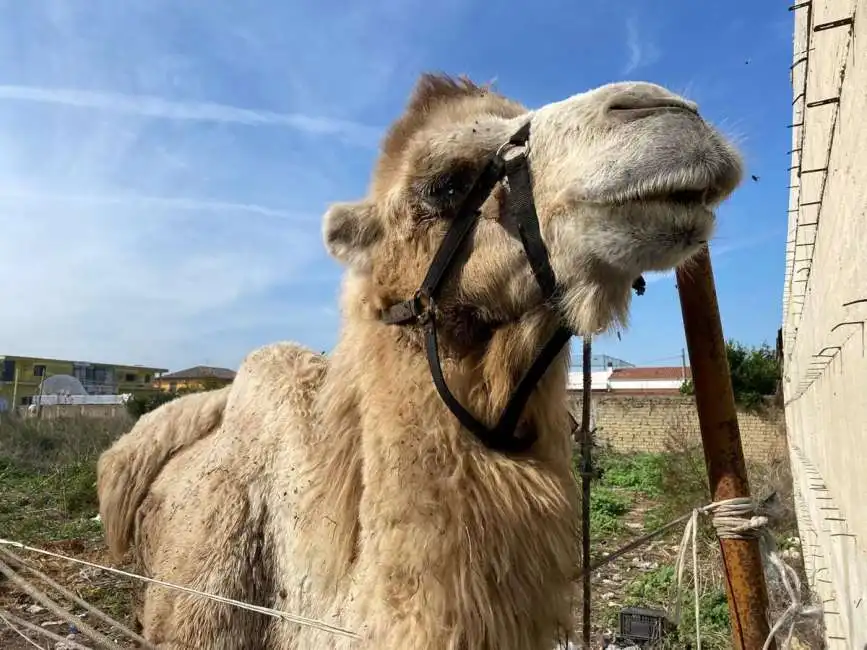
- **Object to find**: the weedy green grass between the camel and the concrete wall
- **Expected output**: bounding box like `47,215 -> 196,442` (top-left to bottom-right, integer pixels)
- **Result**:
576,420 -> 822,649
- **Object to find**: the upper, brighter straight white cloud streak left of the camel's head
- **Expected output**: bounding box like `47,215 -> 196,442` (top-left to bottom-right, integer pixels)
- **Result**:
0,85 -> 381,144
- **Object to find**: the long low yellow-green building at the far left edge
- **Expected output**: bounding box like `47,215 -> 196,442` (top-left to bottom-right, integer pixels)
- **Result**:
0,355 -> 166,411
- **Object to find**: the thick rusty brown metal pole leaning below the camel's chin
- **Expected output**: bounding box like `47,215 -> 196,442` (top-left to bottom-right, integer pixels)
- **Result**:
676,247 -> 776,650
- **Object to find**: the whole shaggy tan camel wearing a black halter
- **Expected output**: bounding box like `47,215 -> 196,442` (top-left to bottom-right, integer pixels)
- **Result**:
98,73 -> 742,650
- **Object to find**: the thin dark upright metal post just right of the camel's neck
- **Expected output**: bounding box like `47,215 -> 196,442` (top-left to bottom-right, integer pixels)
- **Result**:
581,335 -> 593,650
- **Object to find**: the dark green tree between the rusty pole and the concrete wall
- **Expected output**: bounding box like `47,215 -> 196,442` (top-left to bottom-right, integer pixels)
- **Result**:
680,340 -> 781,409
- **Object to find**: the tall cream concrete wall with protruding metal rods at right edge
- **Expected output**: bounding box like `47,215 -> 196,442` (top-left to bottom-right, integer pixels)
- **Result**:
783,0 -> 867,650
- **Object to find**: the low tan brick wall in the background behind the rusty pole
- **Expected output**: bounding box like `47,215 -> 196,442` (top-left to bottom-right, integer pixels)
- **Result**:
572,393 -> 788,462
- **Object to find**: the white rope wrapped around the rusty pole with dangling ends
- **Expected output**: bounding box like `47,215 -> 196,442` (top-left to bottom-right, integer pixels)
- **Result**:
674,497 -> 822,650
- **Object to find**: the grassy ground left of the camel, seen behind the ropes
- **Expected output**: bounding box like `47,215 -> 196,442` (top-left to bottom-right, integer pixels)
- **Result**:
0,414 -> 136,650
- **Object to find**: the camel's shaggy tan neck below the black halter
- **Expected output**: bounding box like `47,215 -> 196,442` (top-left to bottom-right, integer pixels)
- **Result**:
328,320 -> 576,650
